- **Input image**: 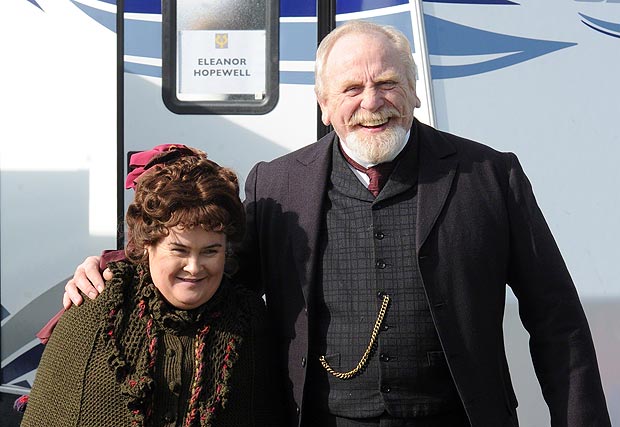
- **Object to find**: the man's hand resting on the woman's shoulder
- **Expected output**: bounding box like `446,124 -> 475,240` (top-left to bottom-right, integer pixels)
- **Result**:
62,256 -> 112,309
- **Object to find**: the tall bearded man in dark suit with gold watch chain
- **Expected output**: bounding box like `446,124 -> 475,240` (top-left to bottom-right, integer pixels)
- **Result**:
65,22 -> 610,427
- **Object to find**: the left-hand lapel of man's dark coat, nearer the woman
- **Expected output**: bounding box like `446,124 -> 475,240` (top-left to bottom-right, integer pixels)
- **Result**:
288,132 -> 335,303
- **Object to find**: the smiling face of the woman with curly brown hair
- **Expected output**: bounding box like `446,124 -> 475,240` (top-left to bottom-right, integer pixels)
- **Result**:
147,227 -> 226,310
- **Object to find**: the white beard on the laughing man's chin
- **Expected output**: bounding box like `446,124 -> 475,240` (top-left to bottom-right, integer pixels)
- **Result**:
345,126 -> 407,164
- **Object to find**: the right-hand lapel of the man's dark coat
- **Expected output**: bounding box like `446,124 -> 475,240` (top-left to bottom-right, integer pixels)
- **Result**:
413,120 -> 458,253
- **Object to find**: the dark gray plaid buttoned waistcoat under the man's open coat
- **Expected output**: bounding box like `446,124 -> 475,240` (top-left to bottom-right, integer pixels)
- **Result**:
310,141 -> 461,418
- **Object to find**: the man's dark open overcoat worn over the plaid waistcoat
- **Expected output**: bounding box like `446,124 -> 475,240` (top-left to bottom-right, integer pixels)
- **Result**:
235,120 -> 610,427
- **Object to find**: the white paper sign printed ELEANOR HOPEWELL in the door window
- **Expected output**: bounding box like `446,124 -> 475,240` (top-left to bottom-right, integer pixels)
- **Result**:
177,30 -> 266,100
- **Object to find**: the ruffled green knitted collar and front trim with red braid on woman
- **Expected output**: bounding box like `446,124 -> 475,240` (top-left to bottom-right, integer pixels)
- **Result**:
102,262 -> 250,427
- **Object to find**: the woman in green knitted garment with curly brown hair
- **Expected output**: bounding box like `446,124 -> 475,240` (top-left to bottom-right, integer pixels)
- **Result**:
22,145 -> 278,427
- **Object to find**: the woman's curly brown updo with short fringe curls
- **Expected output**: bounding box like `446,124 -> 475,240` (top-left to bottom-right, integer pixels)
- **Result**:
125,149 -> 245,264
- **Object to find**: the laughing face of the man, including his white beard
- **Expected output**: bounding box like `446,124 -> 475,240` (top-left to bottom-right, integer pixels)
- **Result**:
319,33 -> 420,163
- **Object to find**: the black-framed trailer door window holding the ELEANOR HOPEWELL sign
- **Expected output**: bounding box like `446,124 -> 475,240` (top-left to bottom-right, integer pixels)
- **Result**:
158,0 -> 280,114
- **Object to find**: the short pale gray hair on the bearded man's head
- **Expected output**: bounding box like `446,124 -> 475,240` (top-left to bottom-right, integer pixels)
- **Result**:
314,21 -> 417,98
